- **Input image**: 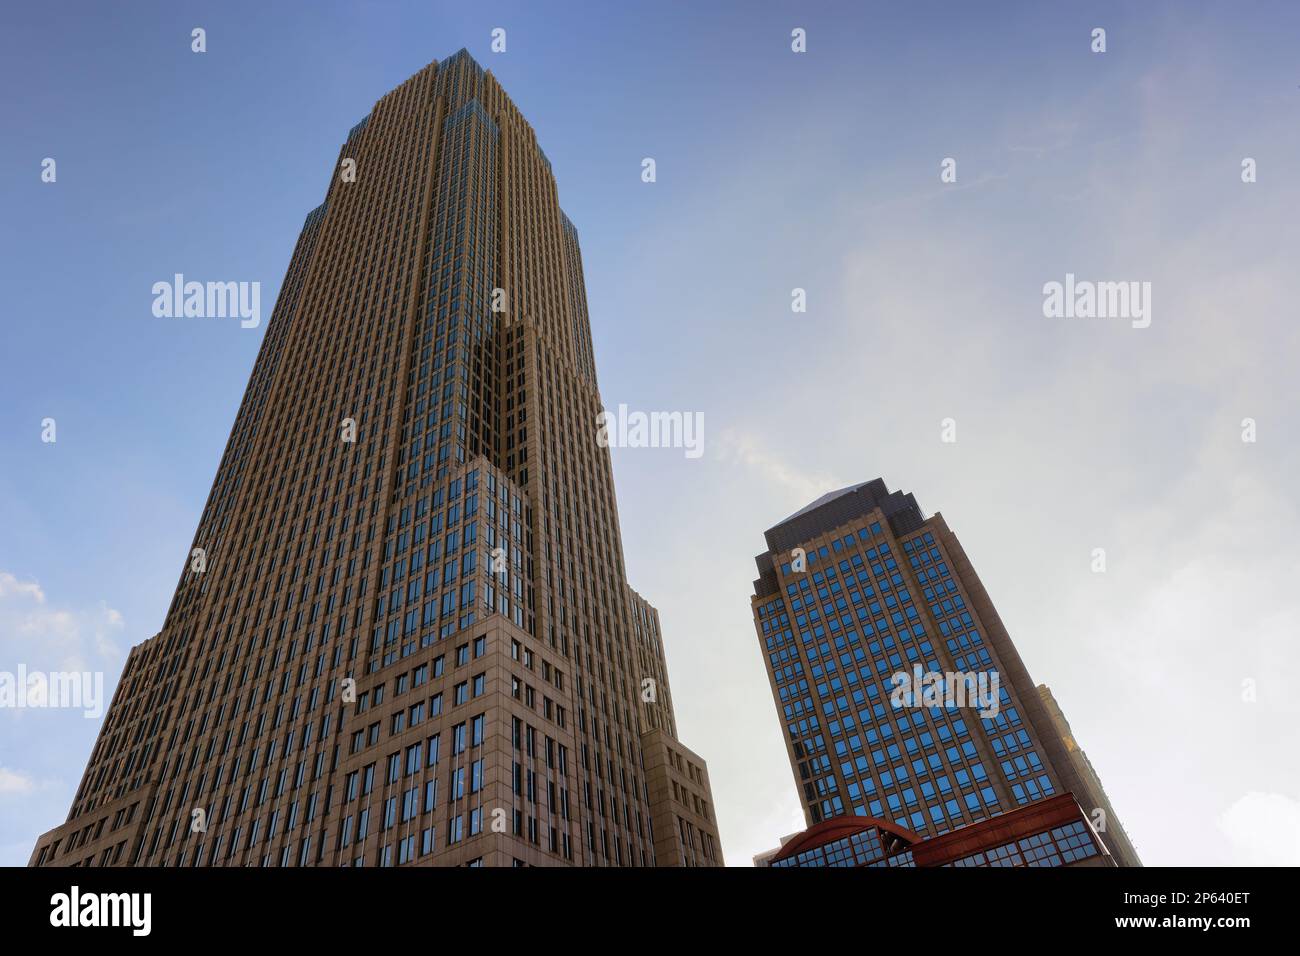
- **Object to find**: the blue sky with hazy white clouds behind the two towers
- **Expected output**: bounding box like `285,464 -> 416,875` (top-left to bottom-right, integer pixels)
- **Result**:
0,3 -> 1300,864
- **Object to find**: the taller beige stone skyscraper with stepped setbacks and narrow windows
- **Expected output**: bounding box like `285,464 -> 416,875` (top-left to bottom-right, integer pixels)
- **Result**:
33,51 -> 722,866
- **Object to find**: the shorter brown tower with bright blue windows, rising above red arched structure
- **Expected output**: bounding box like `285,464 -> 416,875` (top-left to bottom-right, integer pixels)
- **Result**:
753,479 -> 1140,866
